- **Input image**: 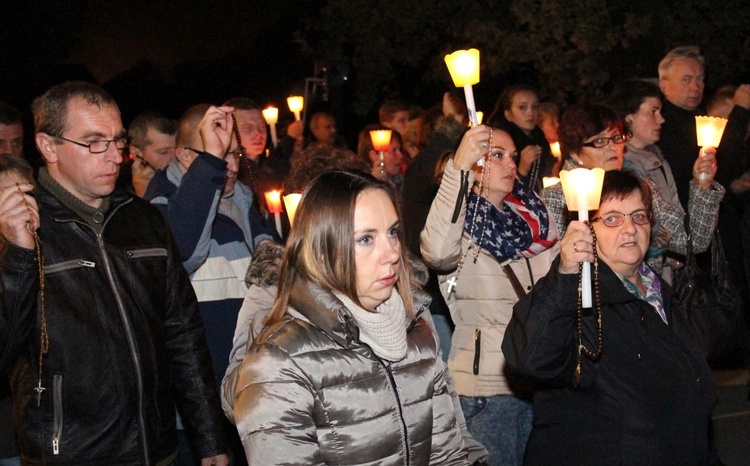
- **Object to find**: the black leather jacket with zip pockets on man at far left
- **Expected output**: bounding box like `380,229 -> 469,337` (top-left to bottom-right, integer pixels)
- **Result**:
0,187 -> 224,465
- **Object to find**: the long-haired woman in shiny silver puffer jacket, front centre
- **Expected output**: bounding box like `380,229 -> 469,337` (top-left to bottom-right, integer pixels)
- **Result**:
234,172 -> 467,465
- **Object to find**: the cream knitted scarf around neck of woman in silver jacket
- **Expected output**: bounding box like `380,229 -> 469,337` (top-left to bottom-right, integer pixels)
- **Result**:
333,288 -> 408,362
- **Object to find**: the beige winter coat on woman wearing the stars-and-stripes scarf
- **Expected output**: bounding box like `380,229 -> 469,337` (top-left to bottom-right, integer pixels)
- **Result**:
421,161 -> 557,396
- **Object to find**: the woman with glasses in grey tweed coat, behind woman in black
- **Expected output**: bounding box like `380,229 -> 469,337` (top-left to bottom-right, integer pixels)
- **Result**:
541,104 -> 724,272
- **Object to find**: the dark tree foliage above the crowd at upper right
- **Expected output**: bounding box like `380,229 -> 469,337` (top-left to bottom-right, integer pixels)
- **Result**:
300,0 -> 750,114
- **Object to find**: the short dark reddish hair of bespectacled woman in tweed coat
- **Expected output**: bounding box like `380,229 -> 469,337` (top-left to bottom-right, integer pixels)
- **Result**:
557,104 -> 622,160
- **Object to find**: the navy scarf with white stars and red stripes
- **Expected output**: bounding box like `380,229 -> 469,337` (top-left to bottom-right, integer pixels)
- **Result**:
464,180 -> 557,263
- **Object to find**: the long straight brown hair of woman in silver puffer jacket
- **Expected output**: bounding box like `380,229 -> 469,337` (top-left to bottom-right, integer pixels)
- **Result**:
266,170 -> 414,325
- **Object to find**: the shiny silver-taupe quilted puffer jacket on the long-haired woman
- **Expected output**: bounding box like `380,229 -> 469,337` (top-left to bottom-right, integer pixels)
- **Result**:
229,281 -> 468,465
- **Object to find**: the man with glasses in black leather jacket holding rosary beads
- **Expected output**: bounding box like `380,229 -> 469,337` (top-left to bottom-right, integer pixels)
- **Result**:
0,82 -> 228,465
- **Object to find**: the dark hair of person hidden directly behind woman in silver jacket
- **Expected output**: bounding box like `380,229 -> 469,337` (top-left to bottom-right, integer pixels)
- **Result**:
284,142 -> 370,194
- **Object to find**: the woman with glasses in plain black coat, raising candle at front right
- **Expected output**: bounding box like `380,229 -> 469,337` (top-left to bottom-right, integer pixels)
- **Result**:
503,171 -> 716,465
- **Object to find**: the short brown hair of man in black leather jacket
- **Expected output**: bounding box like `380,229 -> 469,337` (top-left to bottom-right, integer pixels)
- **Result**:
31,81 -> 120,137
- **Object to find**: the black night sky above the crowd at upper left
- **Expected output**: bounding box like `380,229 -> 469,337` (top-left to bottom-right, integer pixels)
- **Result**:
0,0 -> 315,120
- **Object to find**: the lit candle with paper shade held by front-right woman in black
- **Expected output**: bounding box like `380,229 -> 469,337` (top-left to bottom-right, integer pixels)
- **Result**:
560,168 -> 604,307
